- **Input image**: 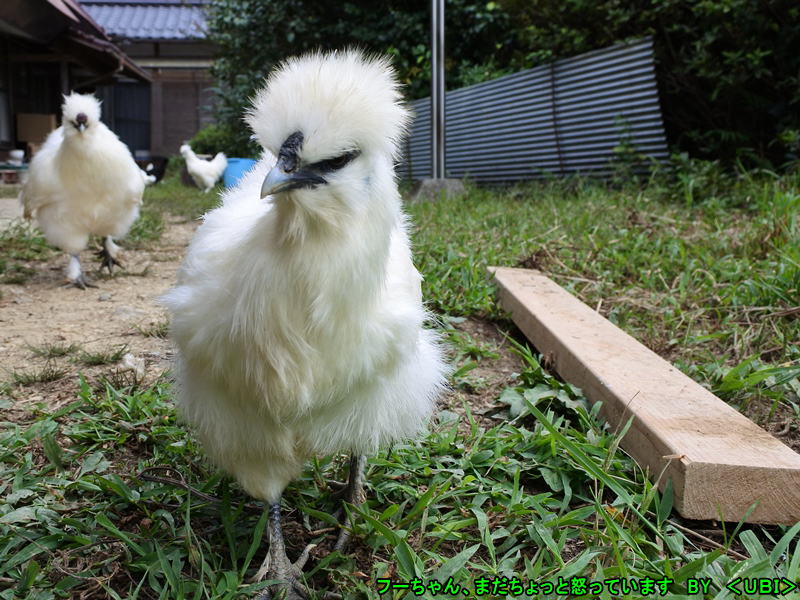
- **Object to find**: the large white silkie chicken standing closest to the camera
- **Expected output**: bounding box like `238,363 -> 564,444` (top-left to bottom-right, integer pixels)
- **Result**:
165,51 -> 446,597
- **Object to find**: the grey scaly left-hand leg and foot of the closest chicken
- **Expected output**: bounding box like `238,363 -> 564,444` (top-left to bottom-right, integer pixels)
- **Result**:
254,500 -> 314,600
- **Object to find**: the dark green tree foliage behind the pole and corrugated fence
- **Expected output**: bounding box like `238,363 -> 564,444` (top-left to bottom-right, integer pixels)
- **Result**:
209,0 -> 800,164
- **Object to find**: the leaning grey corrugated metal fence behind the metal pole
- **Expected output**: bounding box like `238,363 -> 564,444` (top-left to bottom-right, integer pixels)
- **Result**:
398,38 -> 667,183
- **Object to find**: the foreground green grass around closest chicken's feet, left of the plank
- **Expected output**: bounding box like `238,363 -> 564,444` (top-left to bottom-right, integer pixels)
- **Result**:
0,353 -> 800,599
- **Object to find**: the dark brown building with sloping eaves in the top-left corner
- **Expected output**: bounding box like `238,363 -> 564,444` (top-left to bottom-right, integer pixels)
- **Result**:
0,0 -> 151,157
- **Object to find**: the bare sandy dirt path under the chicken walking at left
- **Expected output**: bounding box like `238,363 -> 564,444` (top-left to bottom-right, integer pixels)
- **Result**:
0,219 -> 197,420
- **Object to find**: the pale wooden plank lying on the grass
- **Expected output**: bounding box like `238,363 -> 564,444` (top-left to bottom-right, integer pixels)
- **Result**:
490,267 -> 800,524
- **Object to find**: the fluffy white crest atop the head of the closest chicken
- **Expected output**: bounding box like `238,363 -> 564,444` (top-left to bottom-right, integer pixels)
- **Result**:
247,49 -> 410,161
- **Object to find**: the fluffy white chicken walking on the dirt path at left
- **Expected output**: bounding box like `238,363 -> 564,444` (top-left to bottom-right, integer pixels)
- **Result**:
20,93 -> 145,289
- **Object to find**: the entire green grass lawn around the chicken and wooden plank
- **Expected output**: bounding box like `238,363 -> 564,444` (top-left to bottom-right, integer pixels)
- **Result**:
0,166 -> 800,600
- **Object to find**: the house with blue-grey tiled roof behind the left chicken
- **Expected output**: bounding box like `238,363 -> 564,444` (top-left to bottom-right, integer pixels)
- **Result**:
81,0 -> 214,158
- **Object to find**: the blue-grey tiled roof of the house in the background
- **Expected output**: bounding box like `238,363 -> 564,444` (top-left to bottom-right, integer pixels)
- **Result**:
81,0 -> 206,40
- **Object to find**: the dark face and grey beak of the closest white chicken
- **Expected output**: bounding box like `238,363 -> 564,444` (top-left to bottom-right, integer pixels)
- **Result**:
261,131 -> 361,198
